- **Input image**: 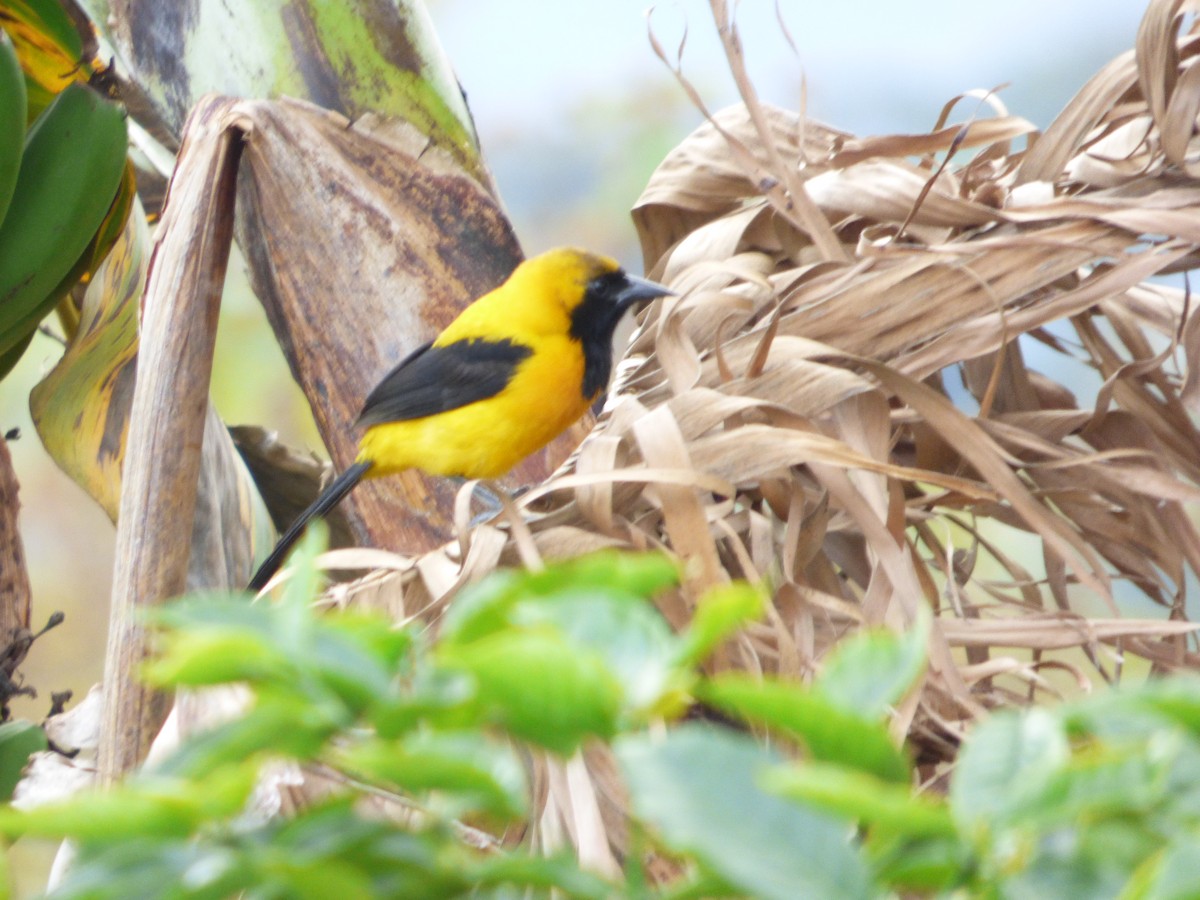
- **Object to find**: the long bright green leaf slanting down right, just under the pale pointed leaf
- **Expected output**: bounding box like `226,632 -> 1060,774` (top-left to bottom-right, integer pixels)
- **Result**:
696,673 -> 911,784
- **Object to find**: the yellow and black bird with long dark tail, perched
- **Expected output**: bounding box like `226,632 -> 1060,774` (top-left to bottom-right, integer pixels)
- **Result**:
248,247 -> 672,593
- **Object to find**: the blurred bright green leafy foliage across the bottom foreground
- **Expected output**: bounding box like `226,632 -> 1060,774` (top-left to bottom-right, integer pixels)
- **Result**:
0,536 -> 1200,898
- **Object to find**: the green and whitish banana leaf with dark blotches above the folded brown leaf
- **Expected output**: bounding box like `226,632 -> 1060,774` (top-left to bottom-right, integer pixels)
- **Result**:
80,0 -> 487,180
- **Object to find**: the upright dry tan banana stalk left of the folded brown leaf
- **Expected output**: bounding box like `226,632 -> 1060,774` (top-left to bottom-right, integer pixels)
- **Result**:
100,103 -> 241,781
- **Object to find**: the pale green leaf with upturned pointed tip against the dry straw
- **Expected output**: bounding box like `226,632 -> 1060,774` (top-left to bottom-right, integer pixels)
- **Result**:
816,607 -> 930,719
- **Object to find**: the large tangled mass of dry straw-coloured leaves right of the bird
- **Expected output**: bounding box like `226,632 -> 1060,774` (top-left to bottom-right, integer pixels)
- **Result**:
309,2 -> 1200,787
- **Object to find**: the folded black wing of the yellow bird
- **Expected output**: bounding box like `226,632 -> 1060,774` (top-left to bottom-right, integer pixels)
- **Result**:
358,340 -> 533,426
